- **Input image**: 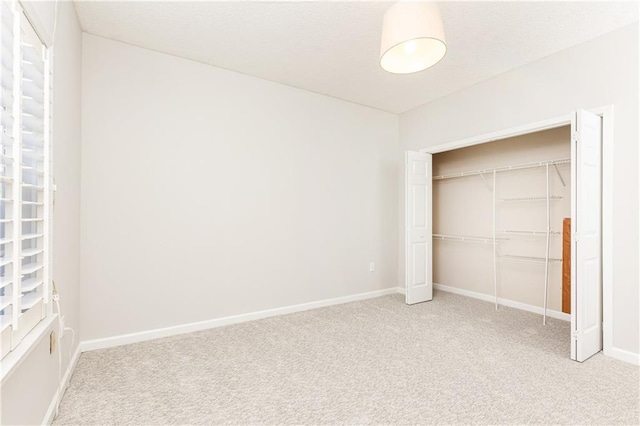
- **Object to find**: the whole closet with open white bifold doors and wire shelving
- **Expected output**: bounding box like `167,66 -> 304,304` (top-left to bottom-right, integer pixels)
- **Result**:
405,111 -> 602,361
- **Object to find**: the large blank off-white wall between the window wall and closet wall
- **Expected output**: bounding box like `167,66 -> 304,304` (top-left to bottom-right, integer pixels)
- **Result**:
80,34 -> 398,340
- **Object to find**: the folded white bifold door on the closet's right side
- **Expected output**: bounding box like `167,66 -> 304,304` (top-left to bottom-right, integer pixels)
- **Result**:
571,110 -> 602,362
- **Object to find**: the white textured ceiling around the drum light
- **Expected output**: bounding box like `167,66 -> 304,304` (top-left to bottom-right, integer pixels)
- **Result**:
76,1 -> 638,113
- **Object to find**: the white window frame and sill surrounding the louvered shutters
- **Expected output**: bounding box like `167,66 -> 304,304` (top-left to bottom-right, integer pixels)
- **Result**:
0,0 -> 57,374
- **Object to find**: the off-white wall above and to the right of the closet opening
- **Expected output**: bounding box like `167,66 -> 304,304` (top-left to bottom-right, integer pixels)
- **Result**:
399,23 -> 640,360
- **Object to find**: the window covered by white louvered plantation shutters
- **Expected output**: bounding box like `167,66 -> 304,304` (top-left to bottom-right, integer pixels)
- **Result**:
0,0 -> 51,359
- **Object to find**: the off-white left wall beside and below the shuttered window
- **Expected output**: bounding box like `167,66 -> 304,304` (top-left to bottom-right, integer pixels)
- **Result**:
0,1 -> 82,425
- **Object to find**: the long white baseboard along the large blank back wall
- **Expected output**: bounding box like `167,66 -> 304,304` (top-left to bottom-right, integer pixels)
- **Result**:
80,287 -> 398,352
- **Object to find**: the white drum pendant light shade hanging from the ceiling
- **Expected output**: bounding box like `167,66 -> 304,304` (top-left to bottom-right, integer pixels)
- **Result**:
380,1 -> 447,74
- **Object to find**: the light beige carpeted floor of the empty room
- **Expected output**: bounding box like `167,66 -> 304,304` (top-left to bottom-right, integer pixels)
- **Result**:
54,292 -> 640,425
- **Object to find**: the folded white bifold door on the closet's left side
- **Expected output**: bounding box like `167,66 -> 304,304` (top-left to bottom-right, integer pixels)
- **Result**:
405,151 -> 433,304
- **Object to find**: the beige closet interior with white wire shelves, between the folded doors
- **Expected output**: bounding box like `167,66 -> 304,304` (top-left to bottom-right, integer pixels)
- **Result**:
432,126 -> 572,322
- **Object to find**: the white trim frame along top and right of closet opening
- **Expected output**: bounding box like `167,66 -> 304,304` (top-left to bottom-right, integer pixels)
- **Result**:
418,105 -> 614,356
